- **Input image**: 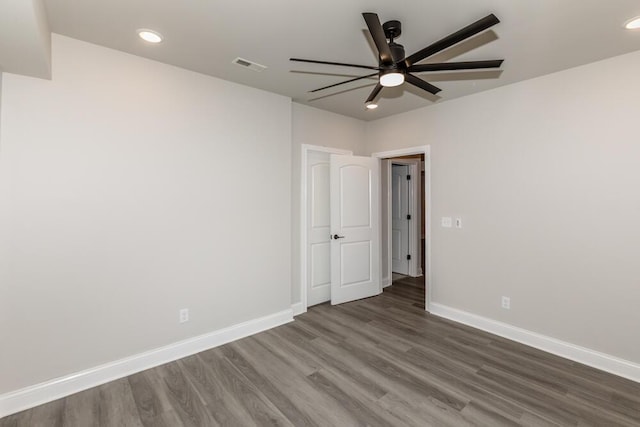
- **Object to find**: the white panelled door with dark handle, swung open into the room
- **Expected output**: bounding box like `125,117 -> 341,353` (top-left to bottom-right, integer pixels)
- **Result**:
330,154 -> 382,304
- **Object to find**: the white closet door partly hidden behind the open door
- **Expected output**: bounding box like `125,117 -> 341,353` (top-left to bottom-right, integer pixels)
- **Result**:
307,152 -> 331,306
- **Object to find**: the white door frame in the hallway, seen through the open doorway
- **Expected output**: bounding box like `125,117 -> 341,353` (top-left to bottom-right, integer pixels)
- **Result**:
382,159 -> 423,280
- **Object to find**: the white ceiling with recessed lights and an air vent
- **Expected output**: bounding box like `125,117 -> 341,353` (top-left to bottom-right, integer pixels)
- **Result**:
40,0 -> 640,120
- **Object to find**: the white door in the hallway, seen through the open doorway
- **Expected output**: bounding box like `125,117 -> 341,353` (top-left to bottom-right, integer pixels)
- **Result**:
391,165 -> 411,274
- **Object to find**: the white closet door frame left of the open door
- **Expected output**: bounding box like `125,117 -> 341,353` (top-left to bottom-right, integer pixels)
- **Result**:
302,144 -> 353,315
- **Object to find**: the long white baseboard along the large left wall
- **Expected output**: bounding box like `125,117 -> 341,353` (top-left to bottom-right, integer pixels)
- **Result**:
0,309 -> 293,418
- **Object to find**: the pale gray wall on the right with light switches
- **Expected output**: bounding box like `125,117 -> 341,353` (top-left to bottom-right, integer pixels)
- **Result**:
365,52 -> 640,362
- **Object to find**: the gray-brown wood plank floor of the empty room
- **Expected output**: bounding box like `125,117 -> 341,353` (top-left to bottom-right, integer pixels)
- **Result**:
0,279 -> 640,427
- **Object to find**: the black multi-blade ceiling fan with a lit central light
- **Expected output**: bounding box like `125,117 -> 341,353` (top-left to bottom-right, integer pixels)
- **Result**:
290,13 -> 503,108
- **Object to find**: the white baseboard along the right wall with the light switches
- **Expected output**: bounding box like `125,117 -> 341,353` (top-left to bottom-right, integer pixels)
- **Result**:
429,303 -> 640,382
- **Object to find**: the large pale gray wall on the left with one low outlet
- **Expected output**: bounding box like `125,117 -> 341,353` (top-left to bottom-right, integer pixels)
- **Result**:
0,36 -> 291,394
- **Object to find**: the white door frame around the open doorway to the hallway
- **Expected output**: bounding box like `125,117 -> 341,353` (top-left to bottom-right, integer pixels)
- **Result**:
371,145 -> 433,311
